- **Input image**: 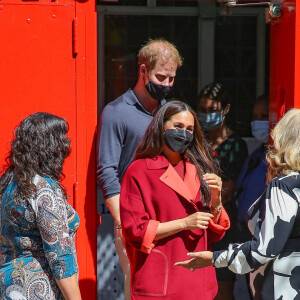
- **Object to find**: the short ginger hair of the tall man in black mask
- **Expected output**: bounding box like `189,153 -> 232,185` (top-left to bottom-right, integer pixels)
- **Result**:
138,39 -> 182,71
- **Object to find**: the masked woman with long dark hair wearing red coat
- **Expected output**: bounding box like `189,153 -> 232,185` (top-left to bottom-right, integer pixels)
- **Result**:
120,101 -> 229,300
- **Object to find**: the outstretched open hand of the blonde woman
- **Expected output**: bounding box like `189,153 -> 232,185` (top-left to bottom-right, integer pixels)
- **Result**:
174,251 -> 213,271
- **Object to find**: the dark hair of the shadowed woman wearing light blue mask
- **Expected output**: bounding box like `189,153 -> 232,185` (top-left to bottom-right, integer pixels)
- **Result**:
198,82 -> 229,108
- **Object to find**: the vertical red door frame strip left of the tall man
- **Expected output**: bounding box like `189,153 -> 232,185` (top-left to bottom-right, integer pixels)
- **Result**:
73,0 -> 99,299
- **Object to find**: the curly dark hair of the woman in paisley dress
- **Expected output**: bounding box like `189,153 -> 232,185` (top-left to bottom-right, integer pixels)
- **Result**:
0,112 -> 70,197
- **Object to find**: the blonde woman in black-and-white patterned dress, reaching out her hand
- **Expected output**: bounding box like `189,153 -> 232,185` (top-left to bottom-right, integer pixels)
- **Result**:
175,109 -> 300,300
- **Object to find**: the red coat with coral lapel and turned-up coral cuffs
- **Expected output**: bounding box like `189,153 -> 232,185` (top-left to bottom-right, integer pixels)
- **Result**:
120,156 -> 230,300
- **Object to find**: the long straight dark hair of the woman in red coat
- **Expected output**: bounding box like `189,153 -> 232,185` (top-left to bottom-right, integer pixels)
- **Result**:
135,100 -> 216,206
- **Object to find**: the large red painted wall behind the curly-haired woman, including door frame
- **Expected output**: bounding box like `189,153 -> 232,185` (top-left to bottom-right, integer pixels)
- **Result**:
0,0 -> 97,299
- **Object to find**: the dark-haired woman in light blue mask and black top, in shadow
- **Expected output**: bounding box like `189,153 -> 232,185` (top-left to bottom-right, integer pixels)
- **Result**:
197,83 -> 248,300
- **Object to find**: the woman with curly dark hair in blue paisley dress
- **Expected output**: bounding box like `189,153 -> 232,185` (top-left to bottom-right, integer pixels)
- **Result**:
0,112 -> 81,300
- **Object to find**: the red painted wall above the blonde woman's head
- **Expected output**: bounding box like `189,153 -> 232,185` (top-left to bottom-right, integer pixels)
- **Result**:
270,0 -> 300,127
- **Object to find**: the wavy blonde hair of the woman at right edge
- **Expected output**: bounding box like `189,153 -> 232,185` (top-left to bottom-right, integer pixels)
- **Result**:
266,108 -> 300,183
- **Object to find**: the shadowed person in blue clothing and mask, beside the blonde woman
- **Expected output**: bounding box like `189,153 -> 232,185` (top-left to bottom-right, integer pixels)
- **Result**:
234,95 -> 269,300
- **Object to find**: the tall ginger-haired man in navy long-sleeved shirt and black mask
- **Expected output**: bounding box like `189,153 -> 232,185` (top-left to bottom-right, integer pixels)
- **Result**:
97,39 -> 182,300
